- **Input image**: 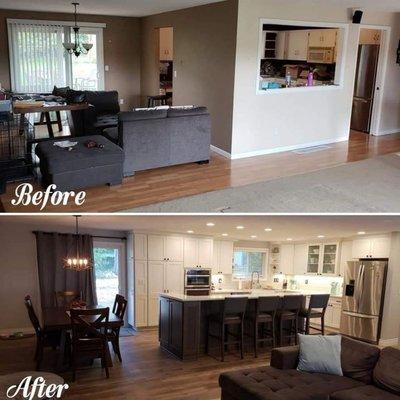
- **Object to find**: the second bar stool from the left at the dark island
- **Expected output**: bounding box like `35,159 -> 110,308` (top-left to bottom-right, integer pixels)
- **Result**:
249,296 -> 280,358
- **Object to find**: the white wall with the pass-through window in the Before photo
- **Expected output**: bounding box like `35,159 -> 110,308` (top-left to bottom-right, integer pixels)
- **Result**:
232,0 -> 400,158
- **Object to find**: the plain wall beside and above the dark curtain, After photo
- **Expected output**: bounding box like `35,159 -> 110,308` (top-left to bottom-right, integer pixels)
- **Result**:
0,217 -> 125,333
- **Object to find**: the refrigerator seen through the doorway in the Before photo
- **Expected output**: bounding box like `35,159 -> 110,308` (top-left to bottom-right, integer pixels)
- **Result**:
351,44 -> 380,133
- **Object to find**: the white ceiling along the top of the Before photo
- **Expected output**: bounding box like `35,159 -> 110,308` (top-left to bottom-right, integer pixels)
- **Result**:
0,0 -> 400,17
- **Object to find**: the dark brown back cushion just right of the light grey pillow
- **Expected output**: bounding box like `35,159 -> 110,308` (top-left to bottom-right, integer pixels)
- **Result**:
342,336 -> 381,384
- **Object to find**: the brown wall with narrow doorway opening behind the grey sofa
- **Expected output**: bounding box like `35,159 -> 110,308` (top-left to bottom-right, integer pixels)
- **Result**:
141,0 -> 237,152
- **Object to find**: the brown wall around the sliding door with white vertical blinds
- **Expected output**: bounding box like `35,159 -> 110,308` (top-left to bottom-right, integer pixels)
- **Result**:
0,10 -> 140,110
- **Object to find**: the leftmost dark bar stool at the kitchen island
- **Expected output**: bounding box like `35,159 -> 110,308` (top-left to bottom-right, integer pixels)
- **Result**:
206,297 -> 248,362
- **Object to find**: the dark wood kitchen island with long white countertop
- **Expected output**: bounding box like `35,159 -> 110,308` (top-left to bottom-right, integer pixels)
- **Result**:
159,289 -> 332,360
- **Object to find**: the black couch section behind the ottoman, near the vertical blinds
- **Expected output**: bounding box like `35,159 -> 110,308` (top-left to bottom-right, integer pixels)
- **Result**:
68,91 -> 120,137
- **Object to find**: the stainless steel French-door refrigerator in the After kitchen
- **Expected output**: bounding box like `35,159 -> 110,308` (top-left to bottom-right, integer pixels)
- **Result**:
340,259 -> 388,344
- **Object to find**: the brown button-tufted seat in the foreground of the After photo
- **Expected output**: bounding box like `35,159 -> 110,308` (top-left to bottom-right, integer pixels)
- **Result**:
219,367 -> 364,400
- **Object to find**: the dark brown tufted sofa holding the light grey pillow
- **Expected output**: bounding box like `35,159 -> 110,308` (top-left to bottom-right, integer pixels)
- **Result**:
219,337 -> 400,400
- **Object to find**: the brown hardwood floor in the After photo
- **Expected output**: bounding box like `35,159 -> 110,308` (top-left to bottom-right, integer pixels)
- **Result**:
0,331 -> 269,400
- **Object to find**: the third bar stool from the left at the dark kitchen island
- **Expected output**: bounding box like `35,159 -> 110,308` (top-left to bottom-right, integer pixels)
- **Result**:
277,295 -> 304,346
